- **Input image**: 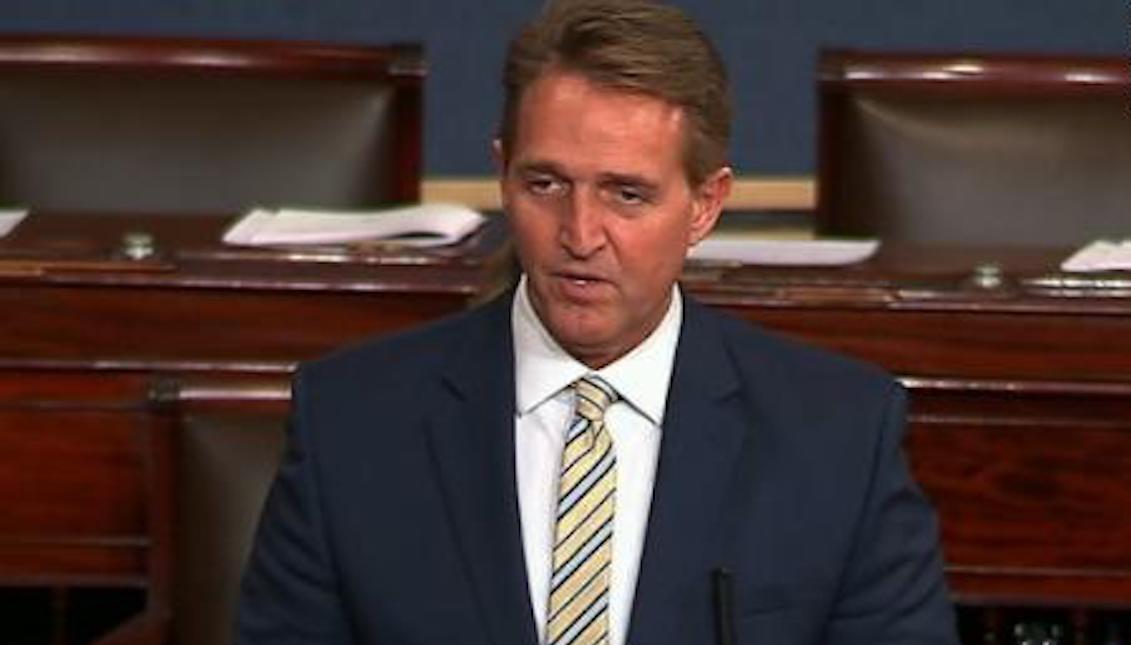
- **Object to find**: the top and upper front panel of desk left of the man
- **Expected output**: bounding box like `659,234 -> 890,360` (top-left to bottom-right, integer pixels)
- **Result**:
0,214 -> 503,371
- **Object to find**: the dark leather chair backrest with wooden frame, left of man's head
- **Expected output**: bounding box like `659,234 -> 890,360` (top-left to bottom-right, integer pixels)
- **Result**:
0,36 -> 424,213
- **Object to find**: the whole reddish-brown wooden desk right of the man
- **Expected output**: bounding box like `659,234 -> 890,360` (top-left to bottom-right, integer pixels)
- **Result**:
685,247 -> 1131,643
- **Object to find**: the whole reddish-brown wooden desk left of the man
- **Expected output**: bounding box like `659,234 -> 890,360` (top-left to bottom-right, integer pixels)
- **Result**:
0,214 -> 506,642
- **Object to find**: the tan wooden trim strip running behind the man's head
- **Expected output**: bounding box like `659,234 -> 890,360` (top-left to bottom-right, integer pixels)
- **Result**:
421,177 -> 817,210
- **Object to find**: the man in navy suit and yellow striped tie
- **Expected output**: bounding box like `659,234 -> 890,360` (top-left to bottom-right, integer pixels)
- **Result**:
238,0 -> 956,645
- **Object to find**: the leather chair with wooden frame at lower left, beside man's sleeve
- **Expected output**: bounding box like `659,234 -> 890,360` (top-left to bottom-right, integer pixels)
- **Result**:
96,378 -> 290,645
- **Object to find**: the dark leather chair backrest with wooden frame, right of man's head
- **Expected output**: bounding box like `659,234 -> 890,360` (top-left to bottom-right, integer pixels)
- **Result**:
817,52 -> 1131,244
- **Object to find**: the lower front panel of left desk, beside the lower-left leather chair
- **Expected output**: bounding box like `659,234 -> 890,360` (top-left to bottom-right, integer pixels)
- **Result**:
0,369 -> 150,586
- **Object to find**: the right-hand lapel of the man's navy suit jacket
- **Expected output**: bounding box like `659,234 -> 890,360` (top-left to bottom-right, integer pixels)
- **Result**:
628,299 -> 749,645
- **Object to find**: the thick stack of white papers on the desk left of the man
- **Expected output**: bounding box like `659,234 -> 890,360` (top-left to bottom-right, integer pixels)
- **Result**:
224,204 -> 486,247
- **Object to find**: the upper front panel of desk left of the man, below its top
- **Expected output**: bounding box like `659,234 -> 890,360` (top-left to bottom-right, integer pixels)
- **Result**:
0,278 -> 472,370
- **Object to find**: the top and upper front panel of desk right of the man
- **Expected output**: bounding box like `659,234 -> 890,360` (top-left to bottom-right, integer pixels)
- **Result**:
688,246 -> 1131,382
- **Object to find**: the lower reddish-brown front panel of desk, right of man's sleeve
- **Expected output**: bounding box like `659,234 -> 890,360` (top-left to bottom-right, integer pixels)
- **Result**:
908,420 -> 1131,583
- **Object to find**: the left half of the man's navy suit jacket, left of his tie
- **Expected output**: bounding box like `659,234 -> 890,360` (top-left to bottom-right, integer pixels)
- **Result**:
238,299 -> 534,645
